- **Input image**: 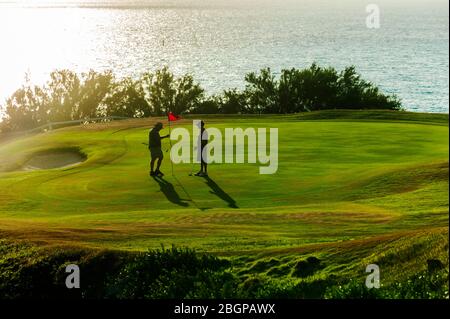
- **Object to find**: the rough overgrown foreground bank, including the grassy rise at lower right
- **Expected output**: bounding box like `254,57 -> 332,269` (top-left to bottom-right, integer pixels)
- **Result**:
0,229 -> 448,299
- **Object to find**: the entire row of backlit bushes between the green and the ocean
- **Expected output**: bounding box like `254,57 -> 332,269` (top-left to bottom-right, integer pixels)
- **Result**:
0,64 -> 401,132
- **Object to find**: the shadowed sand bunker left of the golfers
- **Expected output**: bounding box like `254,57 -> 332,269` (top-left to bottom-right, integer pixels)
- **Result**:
23,150 -> 87,171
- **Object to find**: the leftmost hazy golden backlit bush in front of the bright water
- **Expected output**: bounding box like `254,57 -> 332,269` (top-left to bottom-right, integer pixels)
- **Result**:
0,70 -> 115,132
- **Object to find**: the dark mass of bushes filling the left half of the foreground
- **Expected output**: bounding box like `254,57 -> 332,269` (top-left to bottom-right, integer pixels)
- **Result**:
0,242 -> 237,299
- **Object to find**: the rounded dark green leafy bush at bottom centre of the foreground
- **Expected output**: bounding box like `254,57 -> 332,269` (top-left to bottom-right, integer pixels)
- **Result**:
106,247 -> 234,299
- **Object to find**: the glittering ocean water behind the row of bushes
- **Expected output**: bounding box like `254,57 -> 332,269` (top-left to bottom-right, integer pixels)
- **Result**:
0,0 -> 449,113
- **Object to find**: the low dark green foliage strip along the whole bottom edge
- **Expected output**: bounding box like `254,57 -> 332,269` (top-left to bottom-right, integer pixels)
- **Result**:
0,241 -> 449,299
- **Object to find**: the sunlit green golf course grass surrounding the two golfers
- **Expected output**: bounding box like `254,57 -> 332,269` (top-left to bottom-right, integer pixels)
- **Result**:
0,111 -> 448,288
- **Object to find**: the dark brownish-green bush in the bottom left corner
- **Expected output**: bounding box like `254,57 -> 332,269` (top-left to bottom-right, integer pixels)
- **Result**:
0,243 -> 126,299
